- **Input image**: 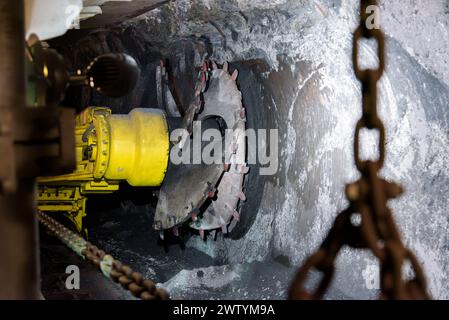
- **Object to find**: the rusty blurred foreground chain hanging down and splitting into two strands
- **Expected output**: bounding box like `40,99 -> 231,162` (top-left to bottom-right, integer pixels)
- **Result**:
289,0 -> 429,299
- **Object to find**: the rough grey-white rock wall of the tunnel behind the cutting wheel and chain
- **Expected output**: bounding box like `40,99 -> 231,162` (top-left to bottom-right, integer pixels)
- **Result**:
54,1 -> 449,298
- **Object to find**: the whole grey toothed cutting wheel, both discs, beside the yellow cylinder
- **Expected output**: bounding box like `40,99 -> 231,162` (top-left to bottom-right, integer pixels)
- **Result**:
154,63 -> 247,234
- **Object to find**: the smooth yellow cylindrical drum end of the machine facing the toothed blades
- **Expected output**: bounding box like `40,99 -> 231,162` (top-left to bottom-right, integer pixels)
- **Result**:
104,108 -> 169,187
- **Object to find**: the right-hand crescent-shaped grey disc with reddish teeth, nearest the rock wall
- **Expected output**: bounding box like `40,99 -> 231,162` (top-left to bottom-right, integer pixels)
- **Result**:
190,63 -> 248,232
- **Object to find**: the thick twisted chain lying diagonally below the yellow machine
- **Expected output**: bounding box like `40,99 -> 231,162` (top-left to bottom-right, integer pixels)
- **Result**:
38,212 -> 169,300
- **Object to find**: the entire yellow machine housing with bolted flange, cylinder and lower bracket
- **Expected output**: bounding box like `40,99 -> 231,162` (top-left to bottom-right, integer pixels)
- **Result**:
38,107 -> 169,234
